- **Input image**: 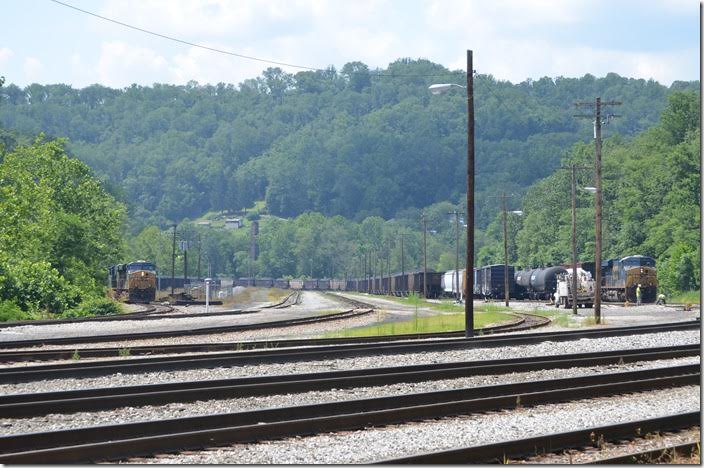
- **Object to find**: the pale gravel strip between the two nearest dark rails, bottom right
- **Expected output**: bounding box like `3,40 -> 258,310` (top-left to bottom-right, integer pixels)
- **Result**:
121,386 -> 700,464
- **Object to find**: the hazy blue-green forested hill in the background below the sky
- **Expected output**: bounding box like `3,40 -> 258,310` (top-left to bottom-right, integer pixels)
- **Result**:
0,60 -> 698,233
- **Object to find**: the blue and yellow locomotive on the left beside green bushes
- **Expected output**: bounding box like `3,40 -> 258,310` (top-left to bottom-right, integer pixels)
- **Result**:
108,260 -> 157,303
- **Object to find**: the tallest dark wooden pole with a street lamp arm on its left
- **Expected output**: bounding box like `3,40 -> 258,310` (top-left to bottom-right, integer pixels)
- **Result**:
428,50 -> 474,338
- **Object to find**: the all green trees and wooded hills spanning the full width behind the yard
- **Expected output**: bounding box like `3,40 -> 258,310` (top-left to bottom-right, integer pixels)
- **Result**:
0,60 -> 701,318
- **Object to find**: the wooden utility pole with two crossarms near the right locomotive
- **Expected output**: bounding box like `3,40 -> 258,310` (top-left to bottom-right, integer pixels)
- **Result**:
575,97 -> 622,324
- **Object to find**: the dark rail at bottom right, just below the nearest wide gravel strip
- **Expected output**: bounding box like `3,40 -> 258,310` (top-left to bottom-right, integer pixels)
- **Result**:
379,411 -> 701,465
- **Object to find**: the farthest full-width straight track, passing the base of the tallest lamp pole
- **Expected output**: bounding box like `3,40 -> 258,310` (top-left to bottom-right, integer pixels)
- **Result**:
0,321 -> 700,372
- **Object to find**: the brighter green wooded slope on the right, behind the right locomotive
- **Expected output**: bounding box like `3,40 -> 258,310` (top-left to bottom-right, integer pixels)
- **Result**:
478,92 -> 701,292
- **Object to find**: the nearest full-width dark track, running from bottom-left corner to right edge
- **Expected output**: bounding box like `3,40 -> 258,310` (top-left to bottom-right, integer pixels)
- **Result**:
0,371 -> 701,463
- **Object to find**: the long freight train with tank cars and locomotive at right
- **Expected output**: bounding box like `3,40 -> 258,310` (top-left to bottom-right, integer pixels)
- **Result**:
233,255 -> 657,305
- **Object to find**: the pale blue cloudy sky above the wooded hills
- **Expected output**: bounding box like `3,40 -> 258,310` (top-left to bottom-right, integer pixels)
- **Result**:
0,0 -> 701,88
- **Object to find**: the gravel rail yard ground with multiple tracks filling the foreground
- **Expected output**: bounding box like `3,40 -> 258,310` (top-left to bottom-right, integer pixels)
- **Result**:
0,291 -> 701,464
